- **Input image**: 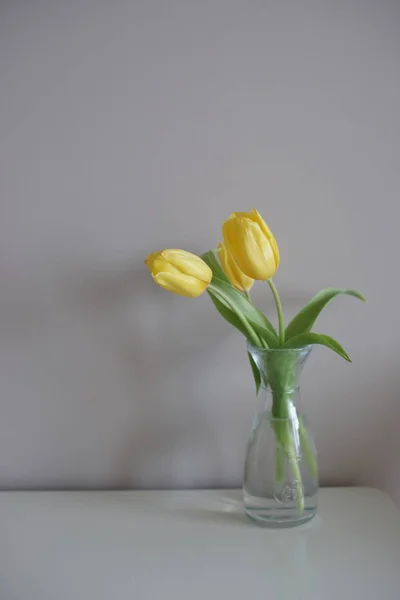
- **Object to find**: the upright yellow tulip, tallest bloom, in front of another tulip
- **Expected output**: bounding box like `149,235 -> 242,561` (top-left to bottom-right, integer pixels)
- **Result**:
222,208 -> 279,280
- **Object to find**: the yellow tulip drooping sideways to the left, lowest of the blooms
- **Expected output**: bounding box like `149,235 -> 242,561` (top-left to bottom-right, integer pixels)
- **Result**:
145,250 -> 212,298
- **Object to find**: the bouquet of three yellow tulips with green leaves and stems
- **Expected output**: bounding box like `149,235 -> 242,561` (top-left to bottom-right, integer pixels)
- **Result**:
146,209 -> 364,510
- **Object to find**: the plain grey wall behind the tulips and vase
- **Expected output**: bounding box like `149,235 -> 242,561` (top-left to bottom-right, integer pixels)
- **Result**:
0,0 -> 400,501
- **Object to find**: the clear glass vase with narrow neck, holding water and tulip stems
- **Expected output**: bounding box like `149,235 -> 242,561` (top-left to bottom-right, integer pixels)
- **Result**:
243,346 -> 318,527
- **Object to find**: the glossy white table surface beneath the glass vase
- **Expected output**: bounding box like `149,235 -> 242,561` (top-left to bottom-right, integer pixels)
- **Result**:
0,488 -> 400,600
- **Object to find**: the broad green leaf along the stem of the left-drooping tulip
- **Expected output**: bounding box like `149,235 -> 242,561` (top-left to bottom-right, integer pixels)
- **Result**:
207,277 -> 279,348
